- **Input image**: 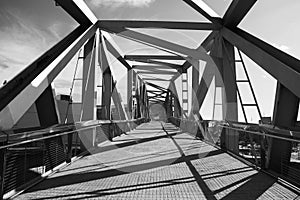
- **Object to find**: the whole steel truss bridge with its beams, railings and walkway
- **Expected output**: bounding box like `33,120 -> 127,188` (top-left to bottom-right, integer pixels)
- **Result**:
0,0 -> 300,199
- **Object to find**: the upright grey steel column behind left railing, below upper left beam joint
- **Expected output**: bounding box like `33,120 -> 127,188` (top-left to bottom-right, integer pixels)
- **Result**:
80,36 -> 96,151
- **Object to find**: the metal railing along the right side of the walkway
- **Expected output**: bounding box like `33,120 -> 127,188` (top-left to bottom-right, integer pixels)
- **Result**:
169,117 -> 300,186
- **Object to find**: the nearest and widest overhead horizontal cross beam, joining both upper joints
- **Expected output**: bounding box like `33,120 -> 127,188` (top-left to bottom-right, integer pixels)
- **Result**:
100,20 -> 222,30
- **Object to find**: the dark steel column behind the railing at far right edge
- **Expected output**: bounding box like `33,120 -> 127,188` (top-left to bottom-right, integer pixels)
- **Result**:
269,82 -> 299,173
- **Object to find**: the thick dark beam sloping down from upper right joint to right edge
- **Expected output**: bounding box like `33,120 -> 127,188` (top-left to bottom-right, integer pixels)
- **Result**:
221,27 -> 300,98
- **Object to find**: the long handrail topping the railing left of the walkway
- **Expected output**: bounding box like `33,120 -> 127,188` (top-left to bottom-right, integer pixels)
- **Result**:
0,118 -> 143,150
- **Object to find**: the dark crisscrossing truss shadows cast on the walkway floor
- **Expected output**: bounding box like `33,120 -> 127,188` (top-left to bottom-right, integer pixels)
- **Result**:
18,124 -> 298,200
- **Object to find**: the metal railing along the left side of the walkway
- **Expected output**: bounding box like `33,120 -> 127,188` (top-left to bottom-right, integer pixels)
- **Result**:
0,119 -> 145,199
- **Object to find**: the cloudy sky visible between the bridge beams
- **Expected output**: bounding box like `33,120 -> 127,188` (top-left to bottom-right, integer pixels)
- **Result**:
0,0 -> 300,121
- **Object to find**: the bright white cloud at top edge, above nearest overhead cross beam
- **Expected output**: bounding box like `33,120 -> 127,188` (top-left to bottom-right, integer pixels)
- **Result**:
91,0 -> 155,8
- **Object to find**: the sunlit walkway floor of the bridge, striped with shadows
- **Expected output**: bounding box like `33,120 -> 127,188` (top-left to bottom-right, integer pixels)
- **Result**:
17,122 -> 300,200
